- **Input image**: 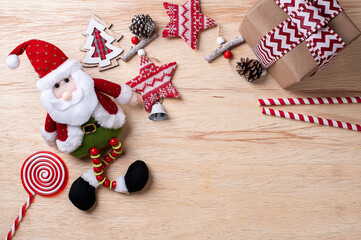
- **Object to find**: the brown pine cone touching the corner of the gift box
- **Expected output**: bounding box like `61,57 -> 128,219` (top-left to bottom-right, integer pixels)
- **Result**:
236,58 -> 263,82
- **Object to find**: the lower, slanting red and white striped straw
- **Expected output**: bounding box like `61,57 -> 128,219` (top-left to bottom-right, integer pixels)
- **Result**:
262,108 -> 361,131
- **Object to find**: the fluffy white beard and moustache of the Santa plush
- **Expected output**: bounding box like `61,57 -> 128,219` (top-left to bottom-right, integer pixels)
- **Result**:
41,70 -> 98,126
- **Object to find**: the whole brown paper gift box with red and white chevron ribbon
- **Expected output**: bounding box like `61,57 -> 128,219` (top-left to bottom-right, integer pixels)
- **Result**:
240,0 -> 360,88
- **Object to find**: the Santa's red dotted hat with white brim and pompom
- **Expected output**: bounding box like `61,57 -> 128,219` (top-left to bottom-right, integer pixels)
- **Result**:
6,39 -> 81,90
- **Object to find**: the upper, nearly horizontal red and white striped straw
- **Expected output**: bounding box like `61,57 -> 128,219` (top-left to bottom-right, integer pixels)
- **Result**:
258,97 -> 361,106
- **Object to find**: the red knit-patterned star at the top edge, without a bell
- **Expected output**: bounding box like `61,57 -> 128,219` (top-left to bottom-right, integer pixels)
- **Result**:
162,0 -> 215,49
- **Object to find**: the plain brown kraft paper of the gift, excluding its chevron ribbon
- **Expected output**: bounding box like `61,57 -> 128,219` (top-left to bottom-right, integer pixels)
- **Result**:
240,0 -> 360,88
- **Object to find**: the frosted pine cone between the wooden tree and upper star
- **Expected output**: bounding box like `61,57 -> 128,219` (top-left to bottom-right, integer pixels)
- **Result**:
129,14 -> 155,38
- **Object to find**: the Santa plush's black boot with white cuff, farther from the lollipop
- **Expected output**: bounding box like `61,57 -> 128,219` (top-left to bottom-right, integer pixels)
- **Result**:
114,160 -> 149,193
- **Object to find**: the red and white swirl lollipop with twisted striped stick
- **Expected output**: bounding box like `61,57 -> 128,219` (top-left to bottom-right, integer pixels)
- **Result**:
5,151 -> 68,240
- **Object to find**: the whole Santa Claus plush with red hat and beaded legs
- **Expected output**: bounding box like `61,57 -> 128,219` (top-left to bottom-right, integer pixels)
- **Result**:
6,40 -> 148,210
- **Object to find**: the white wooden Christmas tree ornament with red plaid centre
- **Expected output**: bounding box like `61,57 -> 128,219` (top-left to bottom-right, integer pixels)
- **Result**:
80,14 -> 123,71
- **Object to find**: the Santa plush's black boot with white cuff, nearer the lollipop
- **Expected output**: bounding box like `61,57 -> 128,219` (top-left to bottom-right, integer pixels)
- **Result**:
69,170 -> 99,211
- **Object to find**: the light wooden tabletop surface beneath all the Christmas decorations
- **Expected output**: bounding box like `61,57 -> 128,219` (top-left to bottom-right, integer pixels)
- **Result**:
0,0 -> 361,239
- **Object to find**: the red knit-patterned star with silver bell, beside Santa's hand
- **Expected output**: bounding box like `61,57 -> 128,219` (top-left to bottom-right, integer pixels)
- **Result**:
126,57 -> 179,112
